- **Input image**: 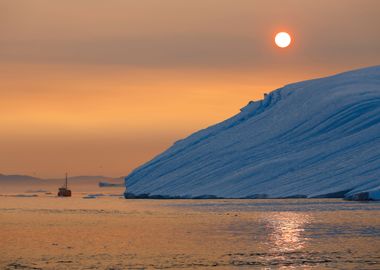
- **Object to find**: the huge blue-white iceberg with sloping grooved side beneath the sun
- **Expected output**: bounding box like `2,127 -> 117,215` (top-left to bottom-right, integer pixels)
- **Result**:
125,66 -> 380,198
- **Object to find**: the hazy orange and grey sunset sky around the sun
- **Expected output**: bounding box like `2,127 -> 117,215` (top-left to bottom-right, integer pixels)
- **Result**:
0,0 -> 380,177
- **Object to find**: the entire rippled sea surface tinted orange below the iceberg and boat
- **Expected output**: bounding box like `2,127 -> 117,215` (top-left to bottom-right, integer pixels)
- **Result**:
0,195 -> 380,269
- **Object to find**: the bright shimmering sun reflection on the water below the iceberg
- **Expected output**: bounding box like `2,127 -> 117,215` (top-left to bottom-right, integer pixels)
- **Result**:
266,212 -> 310,252
